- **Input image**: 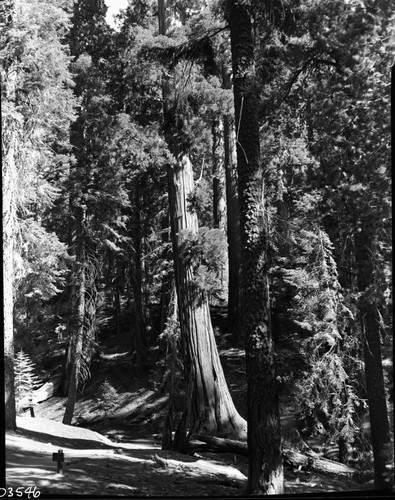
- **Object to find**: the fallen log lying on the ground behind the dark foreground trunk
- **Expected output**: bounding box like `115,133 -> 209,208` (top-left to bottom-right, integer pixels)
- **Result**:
193,434 -> 356,476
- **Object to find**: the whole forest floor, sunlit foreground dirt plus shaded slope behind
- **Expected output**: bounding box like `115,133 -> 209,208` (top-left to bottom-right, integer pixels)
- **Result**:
6,308 -> 386,498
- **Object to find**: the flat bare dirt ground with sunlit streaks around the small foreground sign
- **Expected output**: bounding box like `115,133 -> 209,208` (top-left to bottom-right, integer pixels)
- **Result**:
6,417 -> 374,497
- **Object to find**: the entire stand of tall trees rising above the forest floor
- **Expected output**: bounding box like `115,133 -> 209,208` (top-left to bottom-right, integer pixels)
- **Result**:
1,0 -> 394,493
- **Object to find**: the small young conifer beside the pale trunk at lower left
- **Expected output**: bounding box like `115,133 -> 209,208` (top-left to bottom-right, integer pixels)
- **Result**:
14,349 -> 40,413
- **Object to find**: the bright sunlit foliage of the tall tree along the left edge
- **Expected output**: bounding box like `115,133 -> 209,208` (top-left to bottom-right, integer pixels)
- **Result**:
0,0 -> 77,356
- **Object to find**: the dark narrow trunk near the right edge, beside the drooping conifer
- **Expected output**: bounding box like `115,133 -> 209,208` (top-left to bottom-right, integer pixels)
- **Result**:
355,232 -> 393,489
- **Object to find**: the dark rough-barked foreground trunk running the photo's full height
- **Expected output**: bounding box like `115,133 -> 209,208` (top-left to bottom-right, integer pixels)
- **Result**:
227,0 -> 284,494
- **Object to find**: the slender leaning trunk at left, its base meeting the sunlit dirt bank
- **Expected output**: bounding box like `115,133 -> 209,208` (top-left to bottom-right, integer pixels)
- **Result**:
62,207 -> 86,425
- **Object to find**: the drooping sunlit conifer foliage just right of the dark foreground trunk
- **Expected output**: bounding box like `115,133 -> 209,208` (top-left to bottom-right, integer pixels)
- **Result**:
272,217 -> 366,443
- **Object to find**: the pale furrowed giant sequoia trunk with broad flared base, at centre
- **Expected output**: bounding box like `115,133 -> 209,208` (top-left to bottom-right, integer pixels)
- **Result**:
158,0 -> 246,447
